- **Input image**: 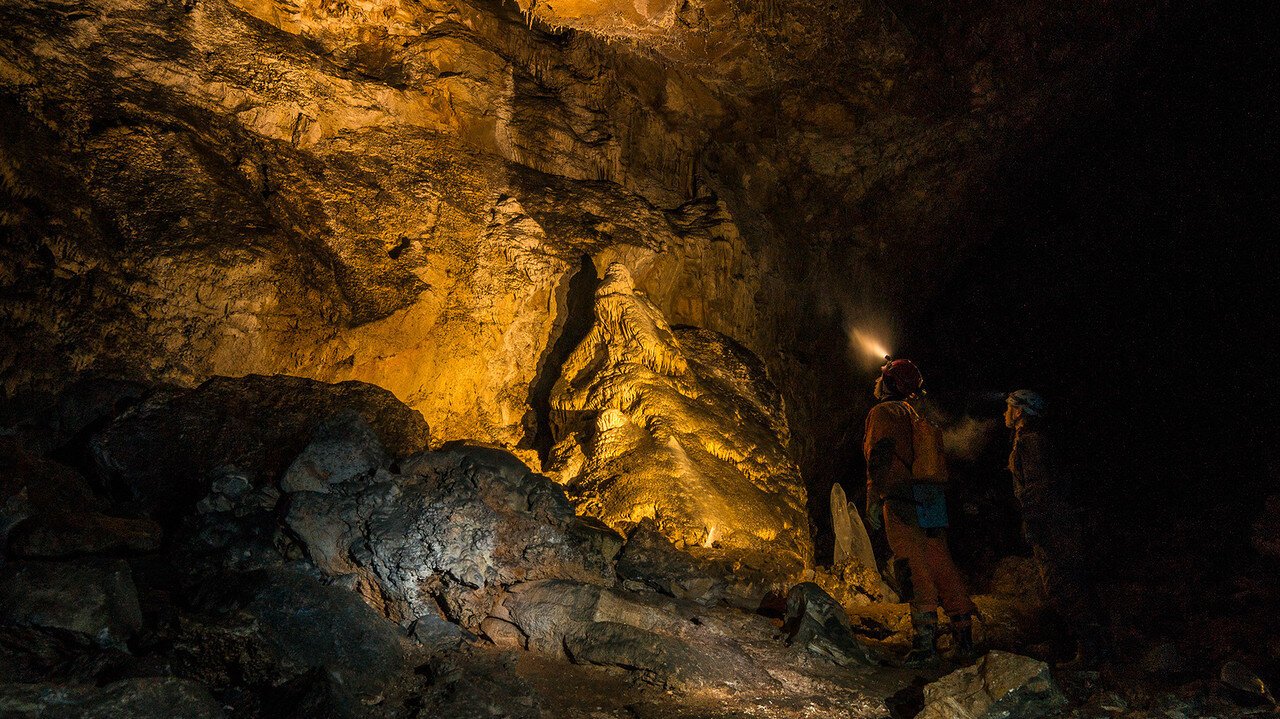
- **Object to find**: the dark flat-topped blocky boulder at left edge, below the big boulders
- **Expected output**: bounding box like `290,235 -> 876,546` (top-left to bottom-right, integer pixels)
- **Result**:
0,559 -> 142,646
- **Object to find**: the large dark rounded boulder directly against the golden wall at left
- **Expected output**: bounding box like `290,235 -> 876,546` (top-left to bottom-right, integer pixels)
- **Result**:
93,375 -> 429,514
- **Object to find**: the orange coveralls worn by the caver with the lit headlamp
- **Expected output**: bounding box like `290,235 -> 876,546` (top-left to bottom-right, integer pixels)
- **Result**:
863,400 -> 975,617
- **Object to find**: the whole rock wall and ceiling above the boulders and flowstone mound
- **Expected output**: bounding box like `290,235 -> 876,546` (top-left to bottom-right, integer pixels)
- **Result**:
0,0 -> 1161,481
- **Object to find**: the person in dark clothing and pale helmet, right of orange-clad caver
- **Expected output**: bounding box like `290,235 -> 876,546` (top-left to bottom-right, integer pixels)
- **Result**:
1005,389 -> 1106,667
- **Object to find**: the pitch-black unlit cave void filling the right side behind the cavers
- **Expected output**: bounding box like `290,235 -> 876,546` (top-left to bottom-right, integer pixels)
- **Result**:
901,4 -> 1280,681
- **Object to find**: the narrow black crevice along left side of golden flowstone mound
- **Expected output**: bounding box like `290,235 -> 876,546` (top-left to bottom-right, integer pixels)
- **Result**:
529,255 -> 600,464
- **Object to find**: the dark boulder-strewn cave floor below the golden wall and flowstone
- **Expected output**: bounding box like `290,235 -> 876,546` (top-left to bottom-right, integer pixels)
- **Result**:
0,376 -> 1280,719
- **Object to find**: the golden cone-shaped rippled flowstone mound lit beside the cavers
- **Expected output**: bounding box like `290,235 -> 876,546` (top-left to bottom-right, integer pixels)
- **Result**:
549,262 -> 812,576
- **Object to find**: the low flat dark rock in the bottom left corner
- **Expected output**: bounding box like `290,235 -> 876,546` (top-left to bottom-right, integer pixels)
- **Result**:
0,677 -> 227,719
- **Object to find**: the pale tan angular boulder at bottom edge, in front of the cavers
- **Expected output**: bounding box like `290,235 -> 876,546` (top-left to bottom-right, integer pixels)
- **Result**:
916,651 -> 1068,719
